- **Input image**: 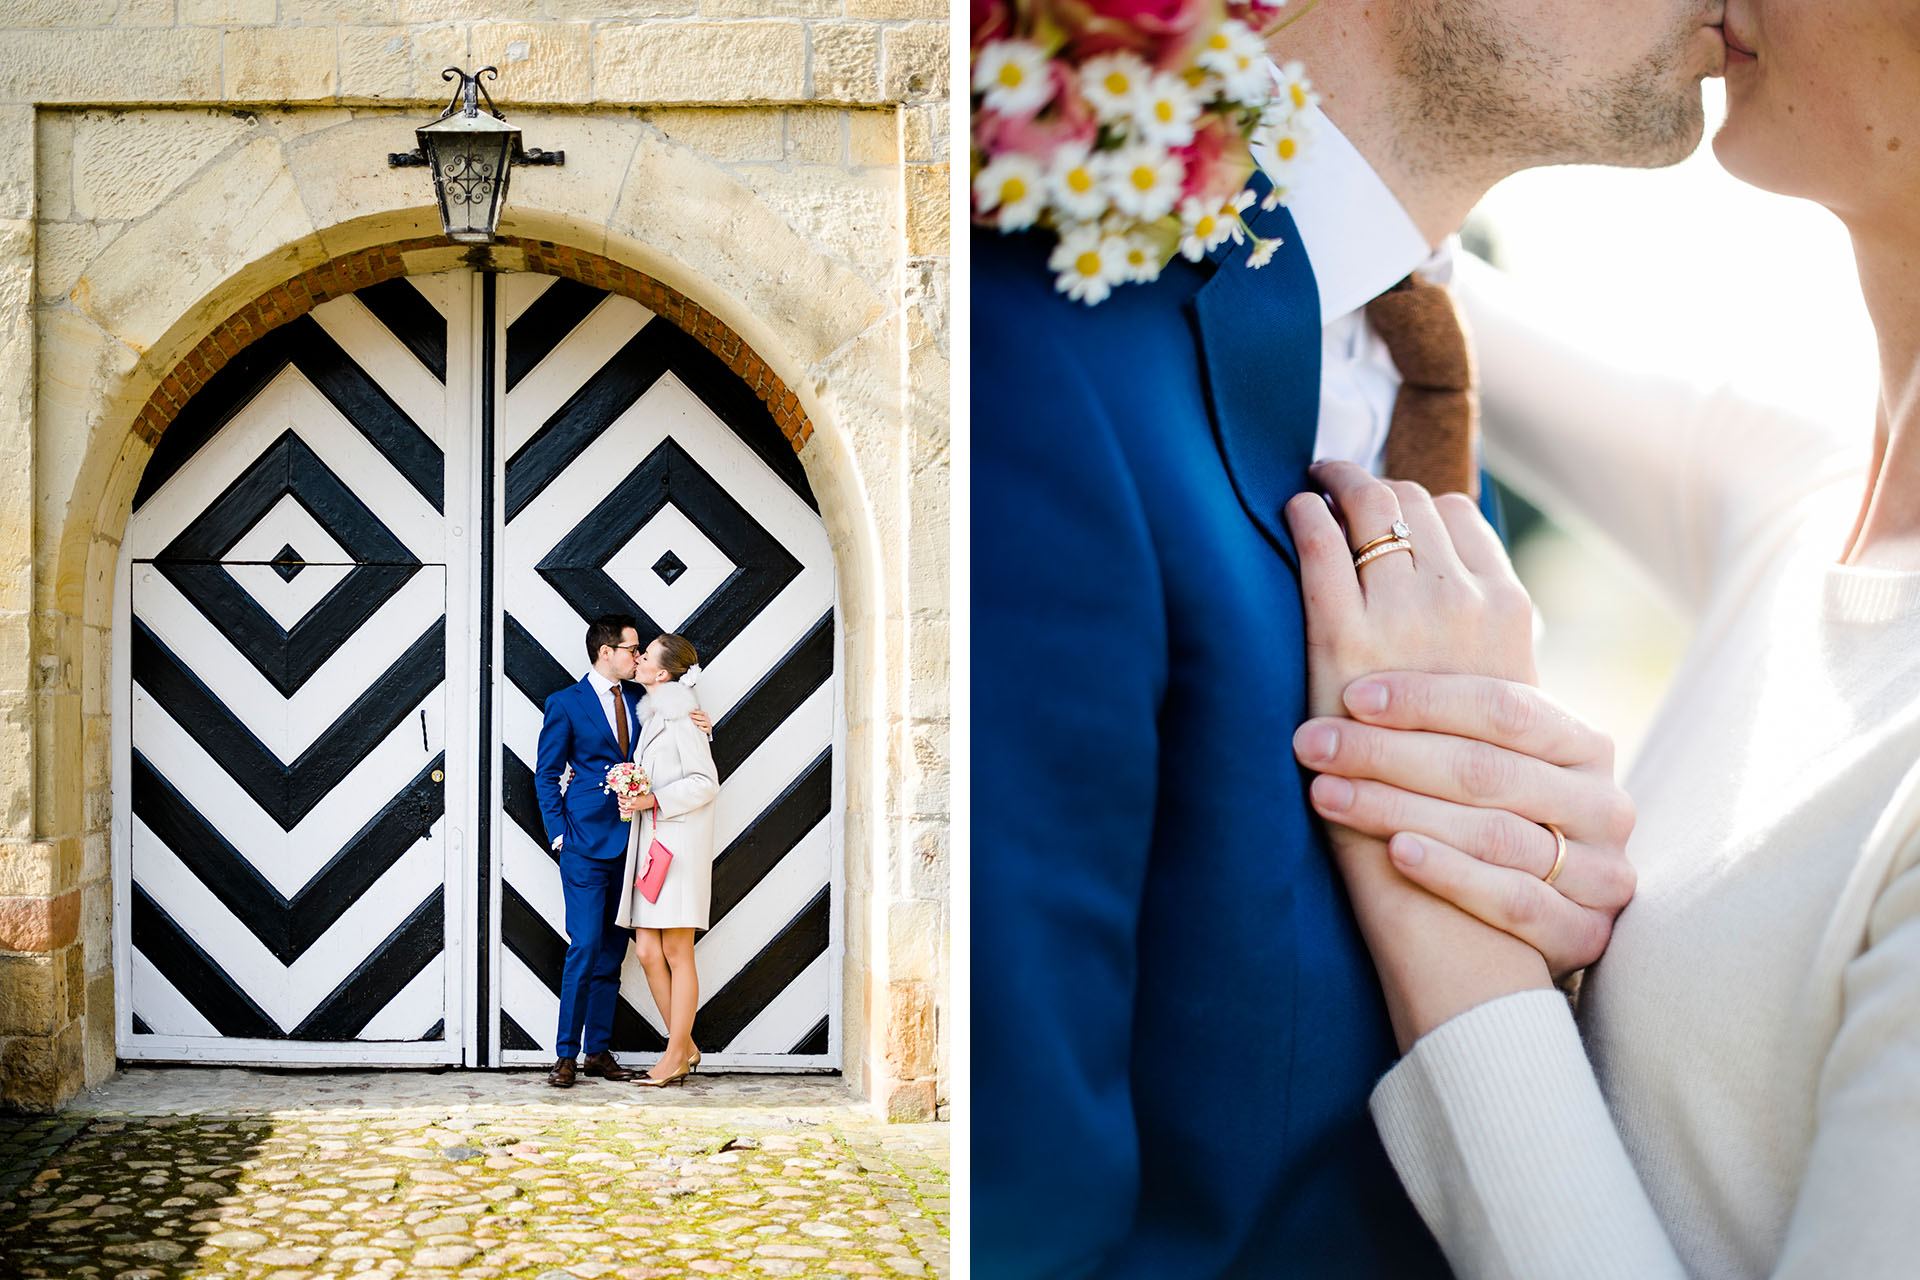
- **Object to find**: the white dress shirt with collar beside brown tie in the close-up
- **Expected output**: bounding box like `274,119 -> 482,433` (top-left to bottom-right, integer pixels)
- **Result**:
1254,107 -> 1455,474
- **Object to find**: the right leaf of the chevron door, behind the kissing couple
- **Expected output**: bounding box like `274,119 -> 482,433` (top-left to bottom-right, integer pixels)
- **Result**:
499,276 -> 839,1067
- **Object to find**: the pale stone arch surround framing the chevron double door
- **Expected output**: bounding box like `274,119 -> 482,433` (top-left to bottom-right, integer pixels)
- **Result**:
22,107 -> 939,1113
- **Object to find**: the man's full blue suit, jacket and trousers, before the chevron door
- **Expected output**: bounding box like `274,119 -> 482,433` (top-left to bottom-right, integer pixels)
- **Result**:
534,676 -> 639,1057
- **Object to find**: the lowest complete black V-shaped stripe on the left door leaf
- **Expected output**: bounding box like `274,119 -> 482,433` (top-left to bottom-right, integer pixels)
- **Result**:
132,750 -> 447,963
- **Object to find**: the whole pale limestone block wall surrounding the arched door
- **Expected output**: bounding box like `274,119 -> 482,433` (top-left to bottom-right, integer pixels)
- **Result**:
0,0 -> 952,1117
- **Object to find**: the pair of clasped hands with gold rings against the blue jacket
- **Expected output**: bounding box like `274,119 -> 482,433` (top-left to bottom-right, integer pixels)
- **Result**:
1286,462 -> 1634,979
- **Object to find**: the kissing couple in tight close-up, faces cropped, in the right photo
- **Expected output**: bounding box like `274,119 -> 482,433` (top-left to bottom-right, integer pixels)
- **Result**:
972,0 -> 1920,1280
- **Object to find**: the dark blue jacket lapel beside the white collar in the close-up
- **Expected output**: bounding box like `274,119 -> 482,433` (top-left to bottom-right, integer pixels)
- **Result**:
1188,186 -> 1321,570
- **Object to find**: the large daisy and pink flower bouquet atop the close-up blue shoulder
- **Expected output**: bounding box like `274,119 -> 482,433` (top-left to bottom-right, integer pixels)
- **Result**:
972,0 -> 1317,307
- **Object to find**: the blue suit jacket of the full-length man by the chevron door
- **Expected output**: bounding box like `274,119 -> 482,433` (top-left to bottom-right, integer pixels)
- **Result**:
534,676 -> 639,858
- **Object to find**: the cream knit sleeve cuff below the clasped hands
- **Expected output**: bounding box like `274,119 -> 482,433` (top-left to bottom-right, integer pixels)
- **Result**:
1373,990 -> 1684,1280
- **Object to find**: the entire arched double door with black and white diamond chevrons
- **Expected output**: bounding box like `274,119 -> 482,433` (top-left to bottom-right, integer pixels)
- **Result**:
113,271 -> 839,1069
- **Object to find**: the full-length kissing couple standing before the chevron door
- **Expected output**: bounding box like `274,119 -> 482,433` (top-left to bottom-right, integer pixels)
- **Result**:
534,614 -> 720,1088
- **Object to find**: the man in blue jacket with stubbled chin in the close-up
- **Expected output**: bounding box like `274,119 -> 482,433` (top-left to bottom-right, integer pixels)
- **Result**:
972,0 -> 1724,1278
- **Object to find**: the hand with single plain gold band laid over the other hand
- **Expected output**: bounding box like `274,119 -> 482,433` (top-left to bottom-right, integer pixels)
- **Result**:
1294,672 -> 1634,977
